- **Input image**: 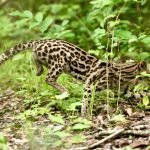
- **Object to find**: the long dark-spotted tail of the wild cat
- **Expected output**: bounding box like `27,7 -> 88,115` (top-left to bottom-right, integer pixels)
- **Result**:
0,41 -> 35,65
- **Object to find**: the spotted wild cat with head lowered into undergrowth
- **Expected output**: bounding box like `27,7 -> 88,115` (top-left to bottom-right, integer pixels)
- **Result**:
0,39 -> 147,117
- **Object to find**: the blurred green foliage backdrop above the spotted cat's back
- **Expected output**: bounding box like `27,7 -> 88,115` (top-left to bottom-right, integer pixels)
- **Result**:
0,0 -> 150,60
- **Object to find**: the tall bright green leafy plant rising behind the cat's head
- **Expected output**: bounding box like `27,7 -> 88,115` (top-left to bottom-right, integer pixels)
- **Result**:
89,0 -> 150,61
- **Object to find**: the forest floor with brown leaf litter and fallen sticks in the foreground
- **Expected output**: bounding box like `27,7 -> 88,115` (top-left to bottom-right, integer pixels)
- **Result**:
0,89 -> 150,150
